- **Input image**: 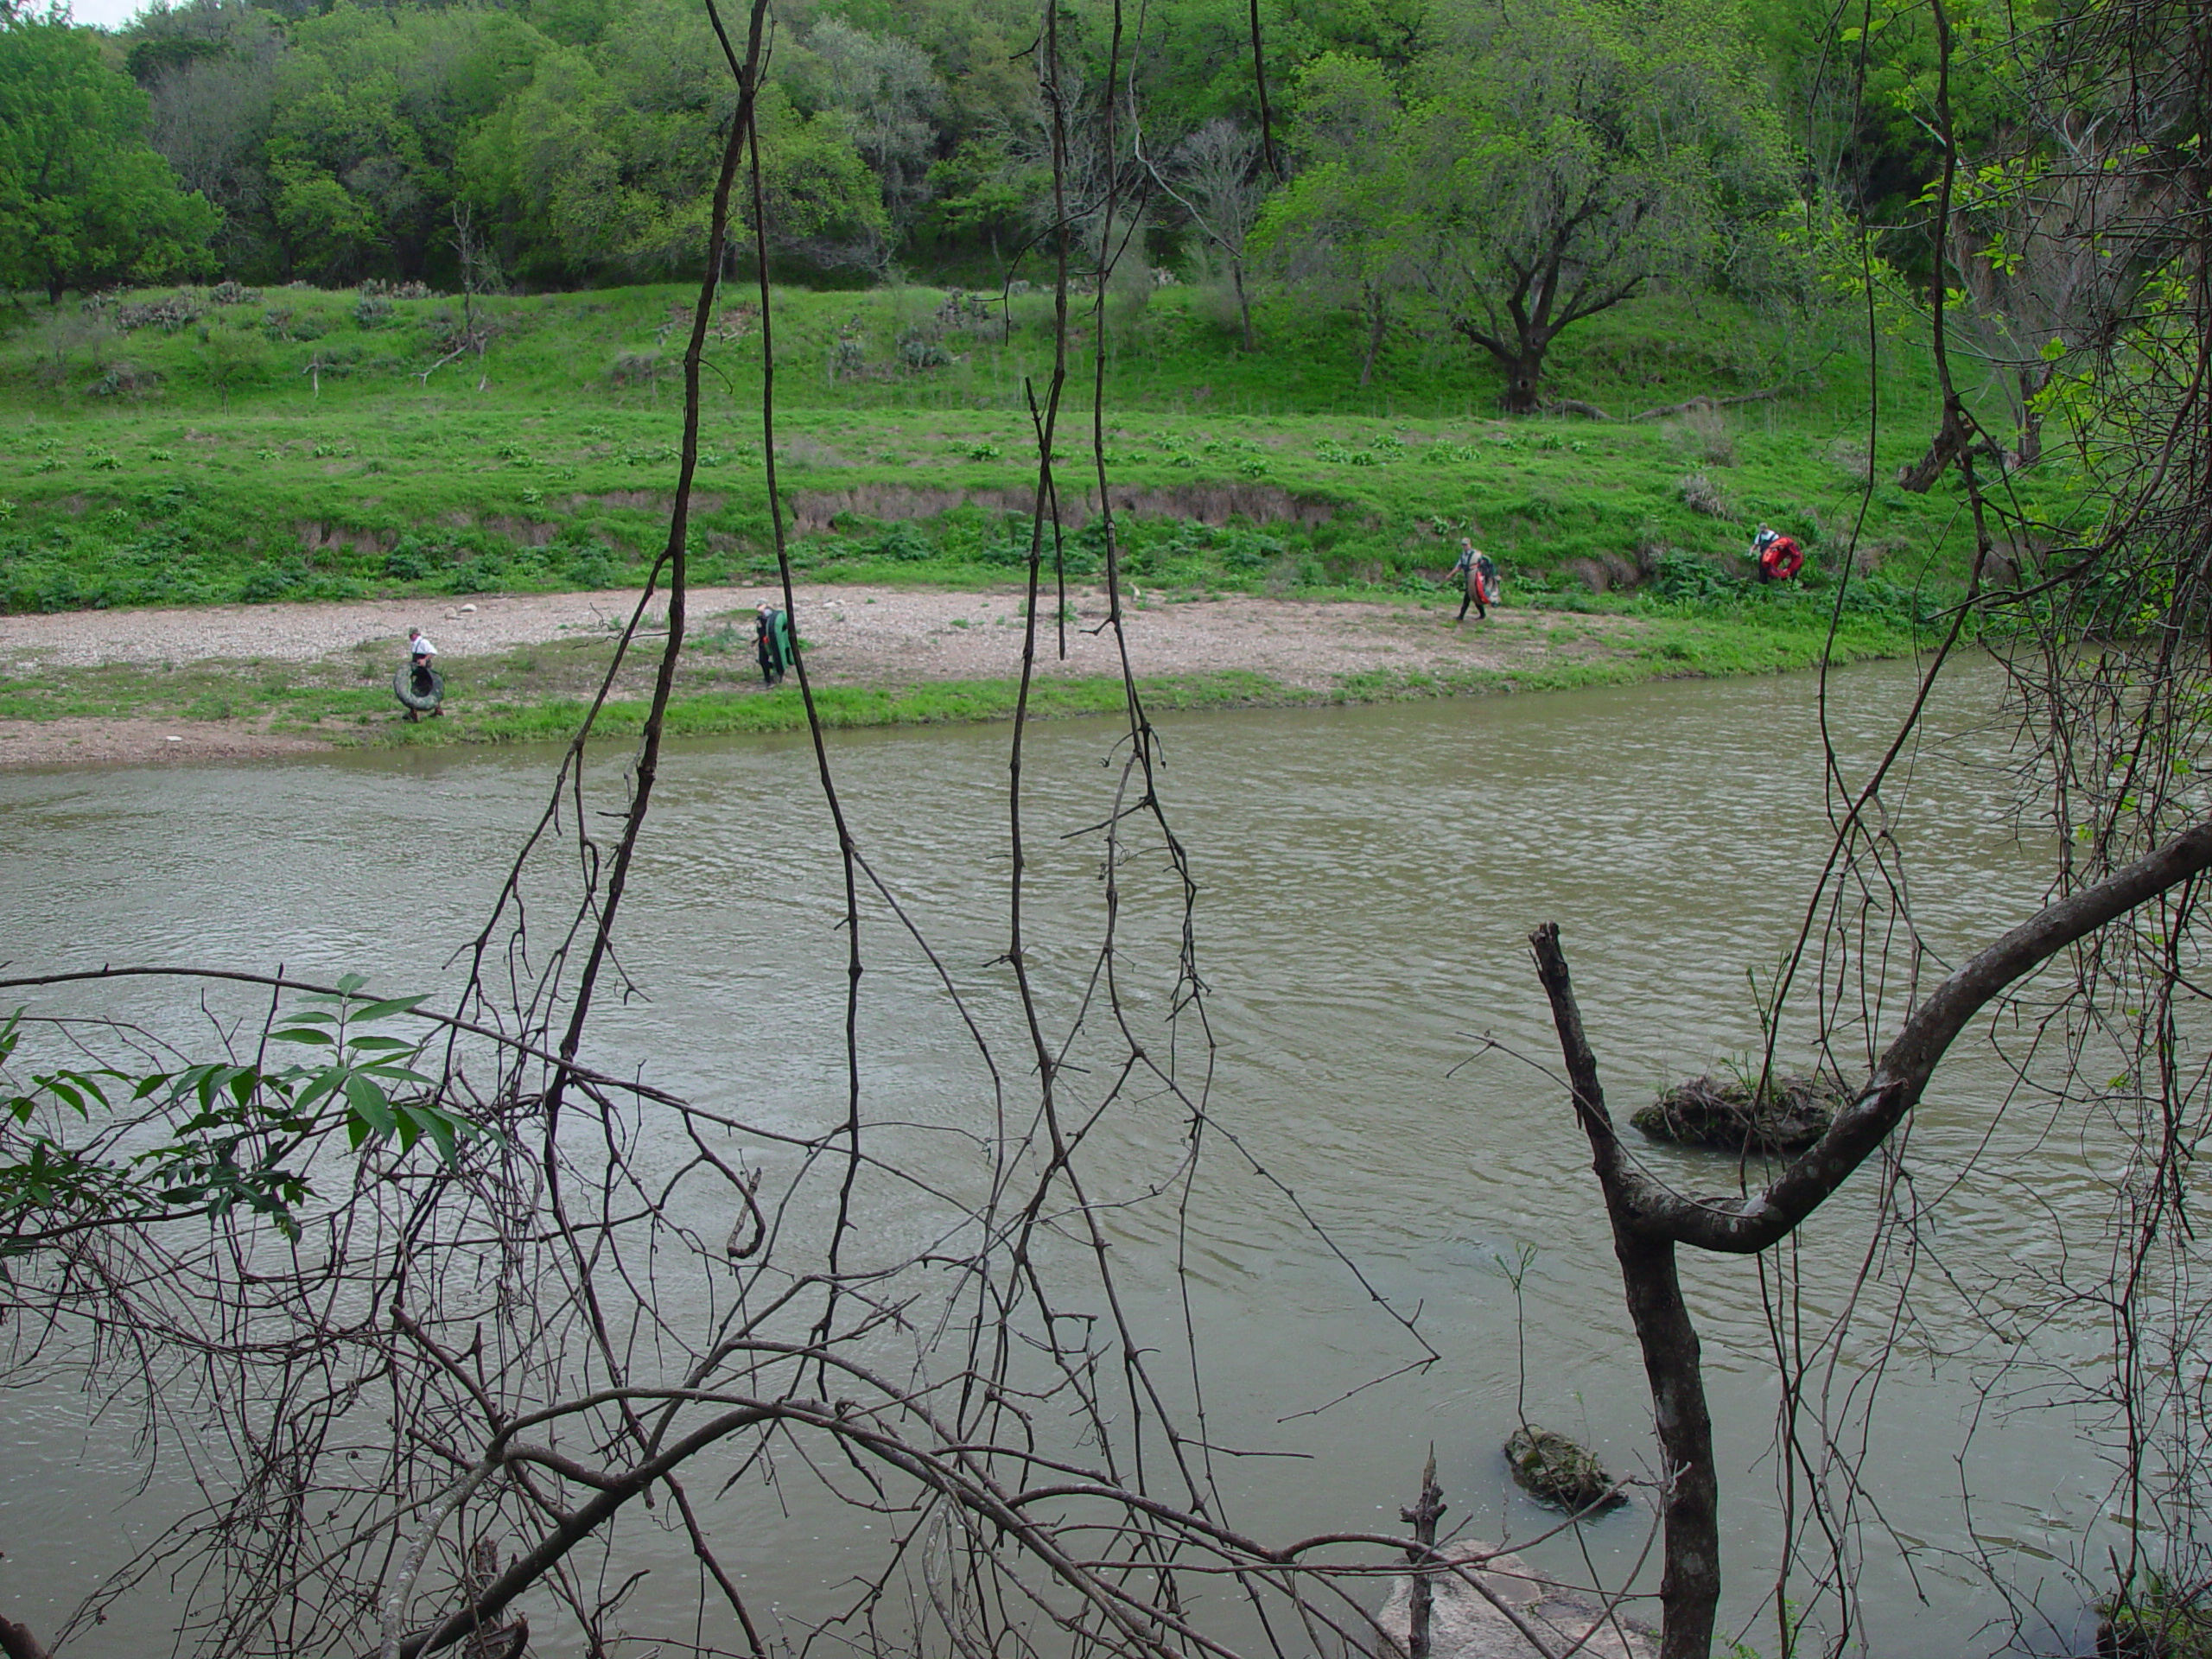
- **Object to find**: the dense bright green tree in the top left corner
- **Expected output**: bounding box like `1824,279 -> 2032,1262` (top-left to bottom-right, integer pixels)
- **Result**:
0,20 -> 221,301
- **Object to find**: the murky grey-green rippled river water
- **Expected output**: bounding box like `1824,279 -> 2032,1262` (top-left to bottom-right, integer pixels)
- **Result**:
0,666 -> 2141,1655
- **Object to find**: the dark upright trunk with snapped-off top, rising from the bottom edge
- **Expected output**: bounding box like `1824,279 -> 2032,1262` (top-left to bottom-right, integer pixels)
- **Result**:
1529,923 -> 1721,1659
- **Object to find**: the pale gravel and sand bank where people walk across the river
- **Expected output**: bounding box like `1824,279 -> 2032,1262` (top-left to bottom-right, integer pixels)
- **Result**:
0,584 -> 1557,767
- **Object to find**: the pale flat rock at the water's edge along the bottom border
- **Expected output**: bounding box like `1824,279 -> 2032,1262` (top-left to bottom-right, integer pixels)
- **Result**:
1376,1544 -> 1659,1659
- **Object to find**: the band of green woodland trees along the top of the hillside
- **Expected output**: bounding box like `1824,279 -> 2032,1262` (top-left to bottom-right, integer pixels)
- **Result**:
0,0 -> 2177,429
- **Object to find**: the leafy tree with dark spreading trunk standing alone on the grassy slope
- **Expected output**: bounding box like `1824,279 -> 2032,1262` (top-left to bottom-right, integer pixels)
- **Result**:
1285,0 -> 1785,411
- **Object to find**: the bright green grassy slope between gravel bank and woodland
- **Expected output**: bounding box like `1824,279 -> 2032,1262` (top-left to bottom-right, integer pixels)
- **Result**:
0,288 -> 2052,611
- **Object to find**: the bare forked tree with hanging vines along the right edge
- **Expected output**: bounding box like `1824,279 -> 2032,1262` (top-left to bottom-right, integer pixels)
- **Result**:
1533,0 -> 2212,1659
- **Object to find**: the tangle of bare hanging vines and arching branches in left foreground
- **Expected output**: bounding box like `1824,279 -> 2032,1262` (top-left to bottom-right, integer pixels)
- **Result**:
0,0 -> 1510,1659
